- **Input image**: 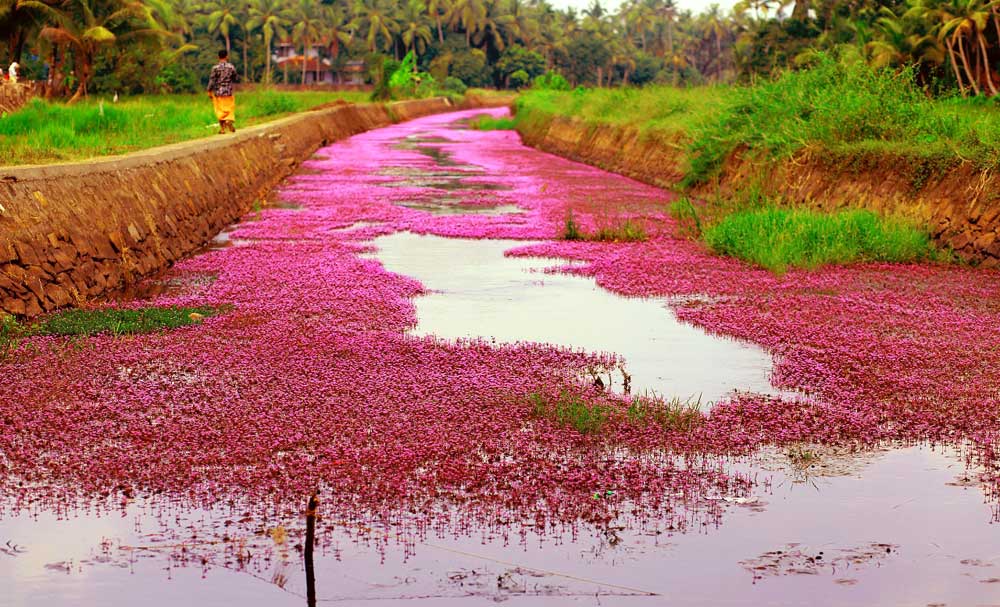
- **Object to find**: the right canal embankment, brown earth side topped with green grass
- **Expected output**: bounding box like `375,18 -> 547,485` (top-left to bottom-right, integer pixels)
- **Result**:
515,81 -> 1000,267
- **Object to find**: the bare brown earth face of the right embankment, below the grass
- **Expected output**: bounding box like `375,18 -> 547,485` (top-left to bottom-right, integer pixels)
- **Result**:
518,112 -> 1000,267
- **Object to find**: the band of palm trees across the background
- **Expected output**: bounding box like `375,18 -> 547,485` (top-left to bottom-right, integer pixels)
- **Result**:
0,0 -> 1000,98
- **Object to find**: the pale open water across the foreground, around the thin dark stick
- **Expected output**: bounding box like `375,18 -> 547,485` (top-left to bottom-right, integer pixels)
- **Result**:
0,448 -> 1000,606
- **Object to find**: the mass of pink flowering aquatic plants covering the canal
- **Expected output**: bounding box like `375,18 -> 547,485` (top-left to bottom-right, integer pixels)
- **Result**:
0,107 -> 1000,540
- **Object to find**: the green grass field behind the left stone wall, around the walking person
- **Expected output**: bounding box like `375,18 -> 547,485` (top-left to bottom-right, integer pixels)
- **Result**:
0,90 -> 365,166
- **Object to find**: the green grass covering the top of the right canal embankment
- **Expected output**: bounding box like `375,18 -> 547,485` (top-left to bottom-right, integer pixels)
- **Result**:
517,57 -> 1000,184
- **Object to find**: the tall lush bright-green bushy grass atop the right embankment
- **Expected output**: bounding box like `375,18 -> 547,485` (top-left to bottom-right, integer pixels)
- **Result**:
685,53 -> 1000,185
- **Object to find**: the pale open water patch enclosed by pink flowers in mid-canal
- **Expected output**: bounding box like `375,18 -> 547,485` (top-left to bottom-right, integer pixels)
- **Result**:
374,233 -> 775,405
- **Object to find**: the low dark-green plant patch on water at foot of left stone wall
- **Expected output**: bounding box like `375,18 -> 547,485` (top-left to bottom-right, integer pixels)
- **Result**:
0,306 -> 229,361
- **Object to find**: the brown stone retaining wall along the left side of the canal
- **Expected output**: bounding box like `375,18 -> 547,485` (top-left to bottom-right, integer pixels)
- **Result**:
0,98 -> 510,316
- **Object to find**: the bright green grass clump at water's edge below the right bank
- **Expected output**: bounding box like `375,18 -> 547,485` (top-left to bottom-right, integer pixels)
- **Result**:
704,206 -> 939,273
